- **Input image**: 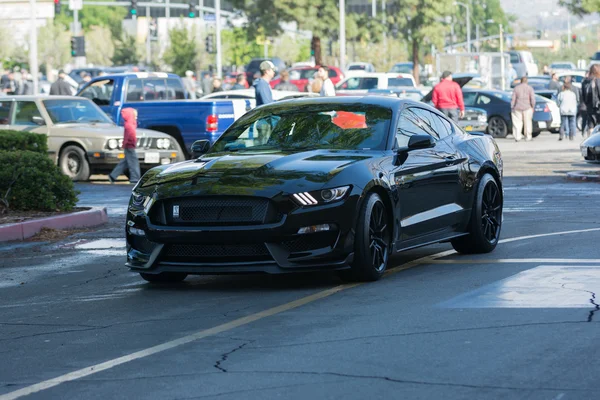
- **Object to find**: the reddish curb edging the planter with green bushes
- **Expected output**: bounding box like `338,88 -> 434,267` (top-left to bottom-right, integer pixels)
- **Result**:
0,207 -> 108,242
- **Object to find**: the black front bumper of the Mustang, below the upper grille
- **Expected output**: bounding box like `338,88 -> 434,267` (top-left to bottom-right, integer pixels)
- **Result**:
126,195 -> 359,274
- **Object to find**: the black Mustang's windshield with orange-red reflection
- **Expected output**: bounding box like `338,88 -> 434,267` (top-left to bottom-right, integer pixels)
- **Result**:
210,104 -> 392,153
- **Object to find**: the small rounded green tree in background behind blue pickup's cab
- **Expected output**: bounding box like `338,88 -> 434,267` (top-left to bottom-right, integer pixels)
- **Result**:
163,24 -> 198,76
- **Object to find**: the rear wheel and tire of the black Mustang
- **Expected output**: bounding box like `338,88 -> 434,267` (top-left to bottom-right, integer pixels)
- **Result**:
451,174 -> 502,254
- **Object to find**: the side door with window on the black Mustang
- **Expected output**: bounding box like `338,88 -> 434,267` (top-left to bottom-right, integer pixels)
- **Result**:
394,107 -> 458,244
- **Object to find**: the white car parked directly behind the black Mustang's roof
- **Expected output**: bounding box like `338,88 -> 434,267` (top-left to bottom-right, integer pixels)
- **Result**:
335,72 -> 416,94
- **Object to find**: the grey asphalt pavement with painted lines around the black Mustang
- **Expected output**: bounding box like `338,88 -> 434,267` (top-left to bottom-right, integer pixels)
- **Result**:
0,133 -> 600,400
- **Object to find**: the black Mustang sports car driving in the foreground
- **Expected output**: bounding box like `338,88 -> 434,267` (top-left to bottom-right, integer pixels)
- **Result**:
126,96 -> 503,282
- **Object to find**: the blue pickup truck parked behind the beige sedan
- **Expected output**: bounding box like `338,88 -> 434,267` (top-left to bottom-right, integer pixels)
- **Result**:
77,72 -> 249,156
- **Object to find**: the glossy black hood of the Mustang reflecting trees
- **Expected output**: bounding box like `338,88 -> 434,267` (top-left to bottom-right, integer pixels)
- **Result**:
142,150 -> 377,197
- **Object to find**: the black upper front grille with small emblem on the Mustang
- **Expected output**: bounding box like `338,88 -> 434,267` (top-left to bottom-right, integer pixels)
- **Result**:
153,196 -> 282,226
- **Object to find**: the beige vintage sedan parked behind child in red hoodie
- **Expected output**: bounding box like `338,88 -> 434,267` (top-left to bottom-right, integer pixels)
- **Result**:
0,95 -> 182,181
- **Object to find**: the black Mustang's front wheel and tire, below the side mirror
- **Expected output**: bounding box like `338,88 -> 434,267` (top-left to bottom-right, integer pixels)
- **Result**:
342,192 -> 392,281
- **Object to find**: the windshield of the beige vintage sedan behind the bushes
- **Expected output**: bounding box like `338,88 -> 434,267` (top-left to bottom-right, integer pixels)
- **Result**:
44,99 -> 112,124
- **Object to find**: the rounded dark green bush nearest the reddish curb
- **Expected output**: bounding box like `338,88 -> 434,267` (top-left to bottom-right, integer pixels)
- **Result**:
0,151 -> 78,212
